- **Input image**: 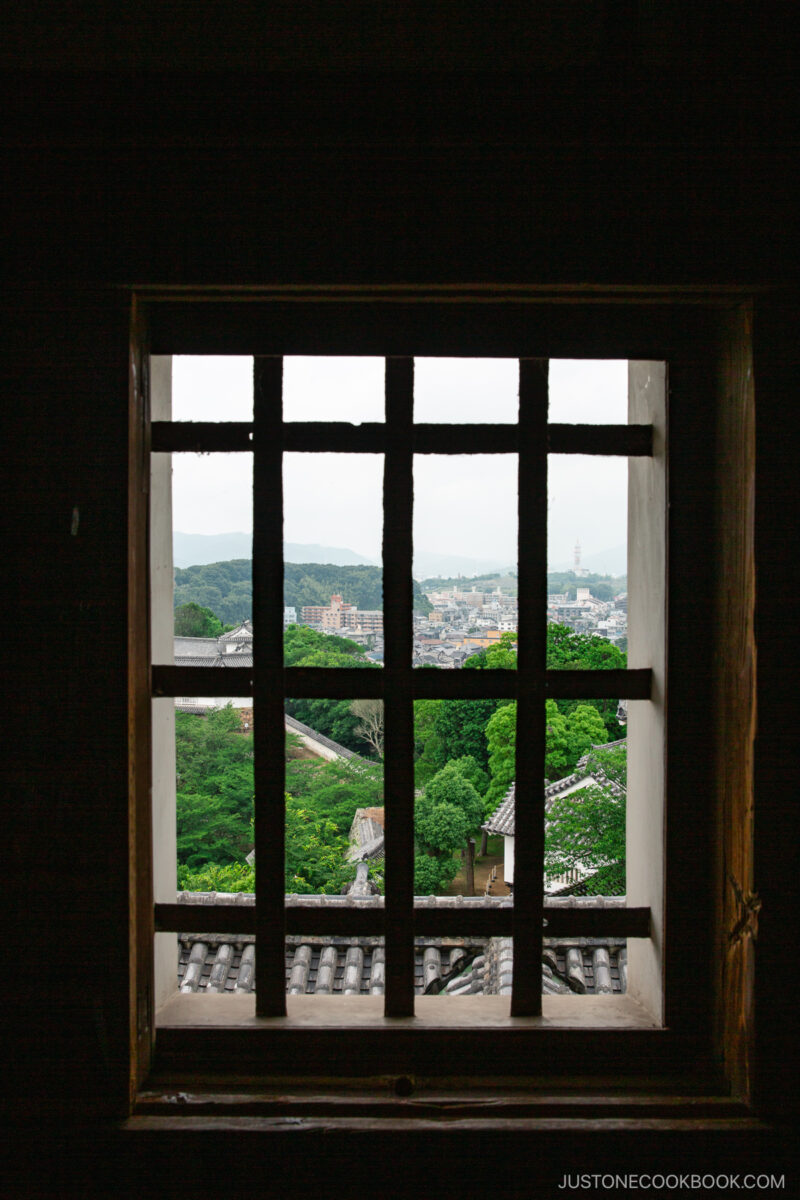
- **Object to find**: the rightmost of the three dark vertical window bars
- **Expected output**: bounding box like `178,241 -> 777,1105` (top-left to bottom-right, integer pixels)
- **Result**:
511,359 -> 548,1016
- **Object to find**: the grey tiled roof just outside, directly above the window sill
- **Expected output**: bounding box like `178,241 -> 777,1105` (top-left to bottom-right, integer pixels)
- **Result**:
178,892 -> 627,996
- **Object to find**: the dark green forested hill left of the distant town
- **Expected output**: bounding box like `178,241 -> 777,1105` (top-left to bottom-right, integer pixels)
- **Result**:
175,558 -> 431,625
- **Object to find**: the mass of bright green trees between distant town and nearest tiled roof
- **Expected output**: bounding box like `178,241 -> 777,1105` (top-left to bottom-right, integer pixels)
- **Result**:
176,607 -> 625,894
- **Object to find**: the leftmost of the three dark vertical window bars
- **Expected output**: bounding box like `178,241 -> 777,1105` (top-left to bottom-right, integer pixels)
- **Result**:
253,358 -> 287,1016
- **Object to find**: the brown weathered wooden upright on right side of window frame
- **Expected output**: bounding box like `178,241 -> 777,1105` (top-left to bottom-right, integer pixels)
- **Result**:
714,305 -> 760,1099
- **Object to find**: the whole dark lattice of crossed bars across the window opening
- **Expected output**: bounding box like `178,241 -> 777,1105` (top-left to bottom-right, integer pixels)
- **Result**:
152,356 -> 652,1016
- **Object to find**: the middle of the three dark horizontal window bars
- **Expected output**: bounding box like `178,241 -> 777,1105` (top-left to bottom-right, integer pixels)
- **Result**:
152,666 -> 652,700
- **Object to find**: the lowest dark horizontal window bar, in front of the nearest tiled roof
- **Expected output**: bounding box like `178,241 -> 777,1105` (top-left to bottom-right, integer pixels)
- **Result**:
155,898 -> 650,937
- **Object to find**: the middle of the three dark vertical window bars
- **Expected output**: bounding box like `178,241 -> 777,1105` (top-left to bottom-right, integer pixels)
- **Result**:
384,359 -> 414,1016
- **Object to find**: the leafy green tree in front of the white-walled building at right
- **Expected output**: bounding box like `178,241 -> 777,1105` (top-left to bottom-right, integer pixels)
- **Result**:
545,745 -> 626,895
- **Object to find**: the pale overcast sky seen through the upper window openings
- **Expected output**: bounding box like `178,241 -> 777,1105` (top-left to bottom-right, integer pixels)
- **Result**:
173,356 -> 627,565
